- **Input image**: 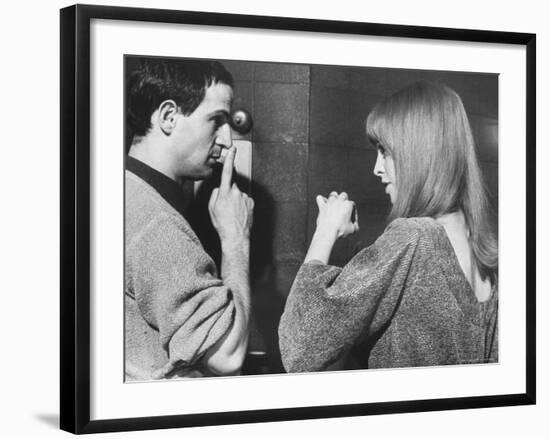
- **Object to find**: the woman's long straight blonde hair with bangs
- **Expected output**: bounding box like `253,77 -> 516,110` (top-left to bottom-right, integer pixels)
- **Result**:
367,82 -> 498,281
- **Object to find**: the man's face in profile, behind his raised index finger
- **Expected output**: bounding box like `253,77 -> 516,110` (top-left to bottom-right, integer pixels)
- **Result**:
172,83 -> 233,180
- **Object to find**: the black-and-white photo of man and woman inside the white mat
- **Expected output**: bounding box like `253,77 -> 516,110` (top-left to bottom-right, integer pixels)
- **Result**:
121,55 -> 499,383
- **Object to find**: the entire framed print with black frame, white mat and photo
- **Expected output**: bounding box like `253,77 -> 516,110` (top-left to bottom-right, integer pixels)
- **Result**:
61,5 -> 536,433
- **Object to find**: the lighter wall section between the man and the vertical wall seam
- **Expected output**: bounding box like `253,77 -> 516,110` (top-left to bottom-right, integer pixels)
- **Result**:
222,61 -> 310,372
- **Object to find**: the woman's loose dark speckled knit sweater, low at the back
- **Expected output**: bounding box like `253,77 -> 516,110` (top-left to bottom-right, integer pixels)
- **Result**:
279,218 -> 498,372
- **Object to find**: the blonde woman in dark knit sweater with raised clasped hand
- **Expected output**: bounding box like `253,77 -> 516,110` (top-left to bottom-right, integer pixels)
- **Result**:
279,82 -> 498,372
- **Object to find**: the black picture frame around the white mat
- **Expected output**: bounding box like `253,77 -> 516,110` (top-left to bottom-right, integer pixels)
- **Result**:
60,5 -> 536,434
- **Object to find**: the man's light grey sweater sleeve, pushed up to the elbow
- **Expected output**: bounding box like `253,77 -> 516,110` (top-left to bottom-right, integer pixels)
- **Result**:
126,215 -> 235,372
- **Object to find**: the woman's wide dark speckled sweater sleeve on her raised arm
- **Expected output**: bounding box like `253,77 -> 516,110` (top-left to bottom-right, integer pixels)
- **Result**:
279,219 -> 421,372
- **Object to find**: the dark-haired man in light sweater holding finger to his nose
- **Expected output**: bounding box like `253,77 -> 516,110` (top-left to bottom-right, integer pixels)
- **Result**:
125,59 -> 253,380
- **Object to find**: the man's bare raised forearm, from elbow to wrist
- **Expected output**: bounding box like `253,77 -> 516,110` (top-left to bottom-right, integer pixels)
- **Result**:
206,238 -> 250,375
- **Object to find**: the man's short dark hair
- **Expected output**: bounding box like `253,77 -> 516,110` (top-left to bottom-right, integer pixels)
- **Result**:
126,58 -> 233,143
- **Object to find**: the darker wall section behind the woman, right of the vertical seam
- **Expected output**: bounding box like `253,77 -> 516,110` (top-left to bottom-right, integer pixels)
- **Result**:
307,66 -> 498,265
